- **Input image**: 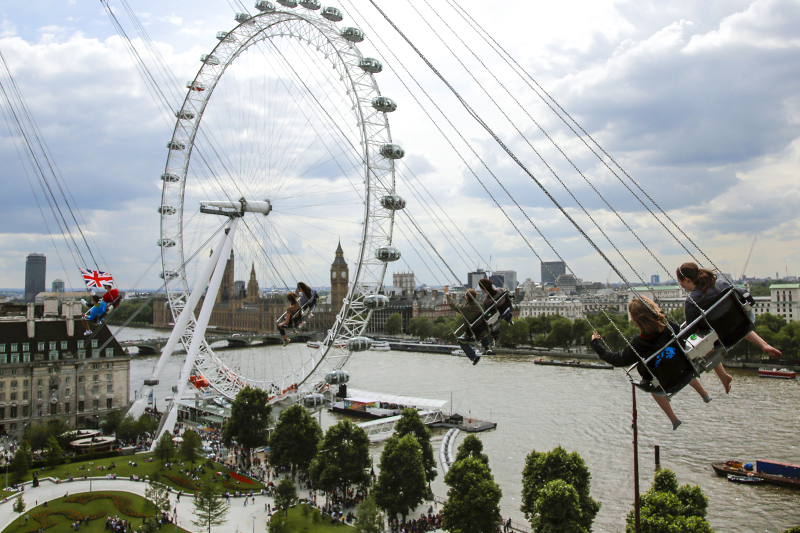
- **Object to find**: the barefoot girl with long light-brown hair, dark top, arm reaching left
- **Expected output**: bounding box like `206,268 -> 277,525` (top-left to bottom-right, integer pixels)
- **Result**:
592,296 -> 724,430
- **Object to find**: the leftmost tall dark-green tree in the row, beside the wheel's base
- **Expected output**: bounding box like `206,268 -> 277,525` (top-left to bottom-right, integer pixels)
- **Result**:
222,387 -> 272,466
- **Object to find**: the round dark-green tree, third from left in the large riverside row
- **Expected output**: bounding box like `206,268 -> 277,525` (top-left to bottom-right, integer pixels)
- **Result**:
308,420 -> 370,494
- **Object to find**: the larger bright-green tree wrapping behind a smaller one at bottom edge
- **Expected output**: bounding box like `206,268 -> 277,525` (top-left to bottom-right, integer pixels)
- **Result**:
520,446 -> 600,531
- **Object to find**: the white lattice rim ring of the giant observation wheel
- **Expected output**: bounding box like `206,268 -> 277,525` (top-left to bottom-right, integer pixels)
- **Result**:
159,9 -> 394,399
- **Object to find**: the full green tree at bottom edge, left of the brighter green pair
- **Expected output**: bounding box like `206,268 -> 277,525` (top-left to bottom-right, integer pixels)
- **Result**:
442,457 -> 503,533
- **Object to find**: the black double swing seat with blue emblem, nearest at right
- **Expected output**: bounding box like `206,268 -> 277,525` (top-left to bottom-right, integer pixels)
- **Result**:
626,287 -> 753,397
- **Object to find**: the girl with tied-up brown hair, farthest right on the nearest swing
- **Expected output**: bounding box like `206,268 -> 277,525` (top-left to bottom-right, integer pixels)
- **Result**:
675,263 -> 781,394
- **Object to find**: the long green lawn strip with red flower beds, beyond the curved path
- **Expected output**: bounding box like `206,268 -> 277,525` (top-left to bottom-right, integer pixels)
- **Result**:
17,453 -> 264,493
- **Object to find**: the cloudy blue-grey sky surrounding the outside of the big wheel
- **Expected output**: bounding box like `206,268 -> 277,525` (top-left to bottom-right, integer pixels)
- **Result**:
0,0 -> 800,288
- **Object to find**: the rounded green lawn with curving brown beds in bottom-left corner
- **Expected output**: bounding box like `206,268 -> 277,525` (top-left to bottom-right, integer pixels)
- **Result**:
2,491 -> 189,533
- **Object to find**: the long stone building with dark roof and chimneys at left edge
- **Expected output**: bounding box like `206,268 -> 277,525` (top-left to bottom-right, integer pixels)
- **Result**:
0,299 -> 131,433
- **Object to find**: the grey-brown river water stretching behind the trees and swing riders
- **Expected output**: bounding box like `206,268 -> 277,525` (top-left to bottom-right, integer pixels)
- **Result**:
118,329 -> 800,533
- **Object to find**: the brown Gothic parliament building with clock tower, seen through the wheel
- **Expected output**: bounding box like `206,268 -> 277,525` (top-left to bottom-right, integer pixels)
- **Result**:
153,242 -> 350,333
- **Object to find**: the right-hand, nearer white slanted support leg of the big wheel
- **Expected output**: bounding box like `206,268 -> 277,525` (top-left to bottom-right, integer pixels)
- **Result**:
150,218 -> 239,450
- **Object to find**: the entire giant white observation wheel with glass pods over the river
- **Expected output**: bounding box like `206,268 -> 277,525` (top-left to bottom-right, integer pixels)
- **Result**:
135,0 -> 405,424
